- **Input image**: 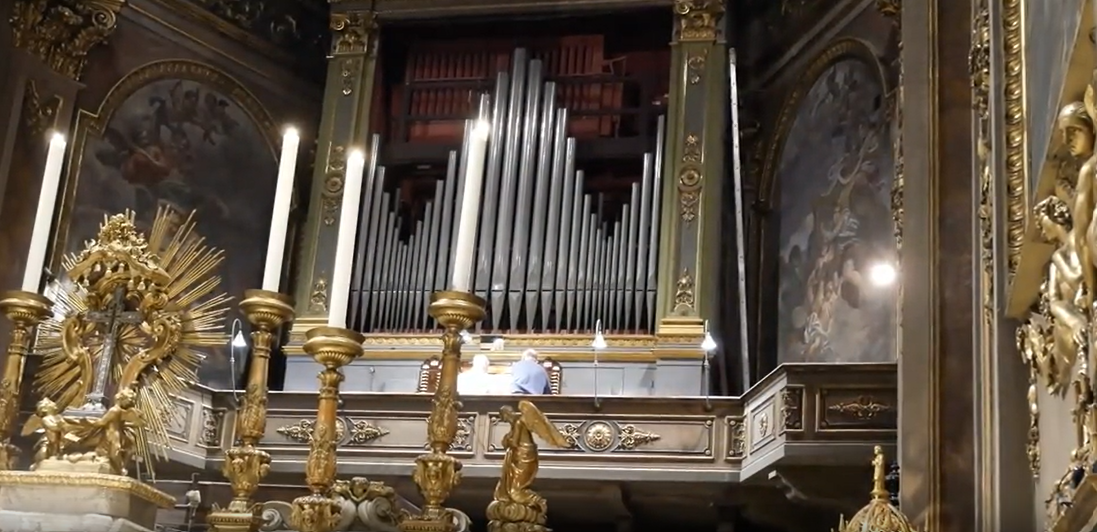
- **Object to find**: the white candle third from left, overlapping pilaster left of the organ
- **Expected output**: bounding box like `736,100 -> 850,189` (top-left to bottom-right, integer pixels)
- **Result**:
328,149 -> 365,328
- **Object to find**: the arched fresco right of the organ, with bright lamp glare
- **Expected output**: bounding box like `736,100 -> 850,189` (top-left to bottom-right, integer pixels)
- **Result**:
773,55 -> 897,362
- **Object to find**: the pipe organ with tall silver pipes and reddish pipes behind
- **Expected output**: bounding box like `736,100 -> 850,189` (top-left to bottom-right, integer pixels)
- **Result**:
350,47 -> 665,332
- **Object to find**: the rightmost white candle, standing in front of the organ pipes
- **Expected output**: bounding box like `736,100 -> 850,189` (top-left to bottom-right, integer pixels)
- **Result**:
450,120 -> 491,292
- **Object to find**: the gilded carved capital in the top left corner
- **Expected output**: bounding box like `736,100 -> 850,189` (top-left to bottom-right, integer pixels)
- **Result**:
11,0 -> 126,79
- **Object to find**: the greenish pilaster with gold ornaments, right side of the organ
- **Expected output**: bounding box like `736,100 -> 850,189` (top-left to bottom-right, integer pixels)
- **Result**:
656,0 -> 728,339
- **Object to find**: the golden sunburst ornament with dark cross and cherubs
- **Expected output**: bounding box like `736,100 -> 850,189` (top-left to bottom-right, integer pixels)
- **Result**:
24,208 -> 230,474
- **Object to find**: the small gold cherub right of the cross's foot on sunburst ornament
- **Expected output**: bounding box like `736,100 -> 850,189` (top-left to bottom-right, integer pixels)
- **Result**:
65,388 -> 143,475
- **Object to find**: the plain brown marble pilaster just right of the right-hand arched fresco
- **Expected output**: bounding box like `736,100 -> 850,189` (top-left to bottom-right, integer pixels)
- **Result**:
898,0 -> 983,532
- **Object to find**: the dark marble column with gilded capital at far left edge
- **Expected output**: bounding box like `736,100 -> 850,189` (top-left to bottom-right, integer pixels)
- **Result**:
0,0 -> 125,410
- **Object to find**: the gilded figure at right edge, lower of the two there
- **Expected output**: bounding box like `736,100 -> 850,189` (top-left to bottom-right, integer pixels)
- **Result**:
1034,196 -> 1088,383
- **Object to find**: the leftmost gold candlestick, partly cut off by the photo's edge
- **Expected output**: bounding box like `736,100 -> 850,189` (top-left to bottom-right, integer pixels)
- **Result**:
0,291 -> 54,471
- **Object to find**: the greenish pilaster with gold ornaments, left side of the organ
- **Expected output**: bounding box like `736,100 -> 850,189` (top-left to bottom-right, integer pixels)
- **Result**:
286,7 -> 378,348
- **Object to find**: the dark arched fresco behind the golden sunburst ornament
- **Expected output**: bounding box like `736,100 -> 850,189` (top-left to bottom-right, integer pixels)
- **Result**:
58,61 -> 278,388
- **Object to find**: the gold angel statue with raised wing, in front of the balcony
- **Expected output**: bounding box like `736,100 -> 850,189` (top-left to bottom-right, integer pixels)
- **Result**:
487,400 -> 568,532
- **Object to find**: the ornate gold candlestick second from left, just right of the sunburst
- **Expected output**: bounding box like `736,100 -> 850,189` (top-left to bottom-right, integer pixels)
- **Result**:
207,290 -> 294,532
